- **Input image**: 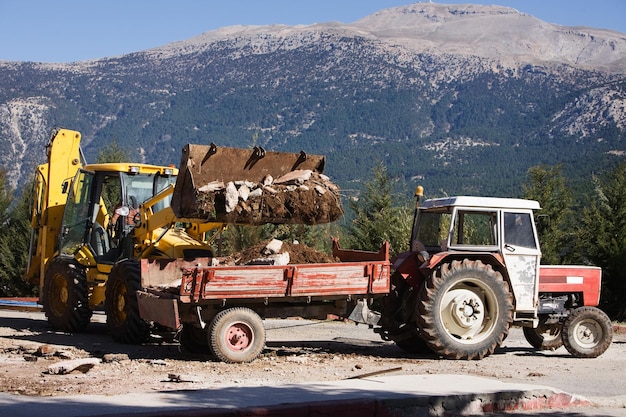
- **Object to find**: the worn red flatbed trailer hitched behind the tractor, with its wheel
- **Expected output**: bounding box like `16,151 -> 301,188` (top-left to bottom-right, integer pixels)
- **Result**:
137,240 -> 391,362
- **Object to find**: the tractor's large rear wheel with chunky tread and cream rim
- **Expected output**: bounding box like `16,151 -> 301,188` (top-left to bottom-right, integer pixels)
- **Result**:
418,259 -> 513,360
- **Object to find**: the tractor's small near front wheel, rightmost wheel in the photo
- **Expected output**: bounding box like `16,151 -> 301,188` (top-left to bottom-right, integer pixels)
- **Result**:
562,307 -> 613,358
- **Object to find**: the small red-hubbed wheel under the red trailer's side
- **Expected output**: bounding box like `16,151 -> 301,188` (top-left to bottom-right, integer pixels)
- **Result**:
209,307 -> 265,363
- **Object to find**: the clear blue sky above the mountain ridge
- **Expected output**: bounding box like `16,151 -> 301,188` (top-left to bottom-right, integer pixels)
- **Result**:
0,0 -> 626,62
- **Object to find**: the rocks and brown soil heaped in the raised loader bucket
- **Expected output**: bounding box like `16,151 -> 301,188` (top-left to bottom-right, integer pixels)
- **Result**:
194,170 -> 343,225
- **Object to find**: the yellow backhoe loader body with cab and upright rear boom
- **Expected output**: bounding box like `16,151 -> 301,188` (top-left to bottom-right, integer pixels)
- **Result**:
26,129 -> 215,331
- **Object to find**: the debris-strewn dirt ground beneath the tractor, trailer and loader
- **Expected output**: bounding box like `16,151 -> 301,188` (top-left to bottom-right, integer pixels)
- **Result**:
0,310 -> 626,398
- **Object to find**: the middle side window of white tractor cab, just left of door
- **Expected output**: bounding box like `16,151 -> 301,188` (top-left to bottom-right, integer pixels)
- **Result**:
450,210 -> 498,248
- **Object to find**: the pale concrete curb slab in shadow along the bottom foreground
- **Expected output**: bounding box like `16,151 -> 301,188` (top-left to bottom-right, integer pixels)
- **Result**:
0,374 -> 592,417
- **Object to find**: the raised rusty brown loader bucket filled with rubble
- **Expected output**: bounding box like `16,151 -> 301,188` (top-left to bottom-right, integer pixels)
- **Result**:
172,144 -> 343,225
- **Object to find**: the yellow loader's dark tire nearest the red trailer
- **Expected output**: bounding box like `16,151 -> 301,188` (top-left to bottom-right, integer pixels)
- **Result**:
104,260 -> 150,344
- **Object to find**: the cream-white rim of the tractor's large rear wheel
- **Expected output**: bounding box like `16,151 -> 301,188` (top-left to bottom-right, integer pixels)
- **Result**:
440,279 -> 498,344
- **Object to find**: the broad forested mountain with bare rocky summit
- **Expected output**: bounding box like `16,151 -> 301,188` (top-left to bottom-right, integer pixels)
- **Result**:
0,3 -> 626,196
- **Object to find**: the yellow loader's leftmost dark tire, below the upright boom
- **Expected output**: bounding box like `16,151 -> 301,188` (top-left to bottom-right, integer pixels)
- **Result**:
42,258 -> 92,333
